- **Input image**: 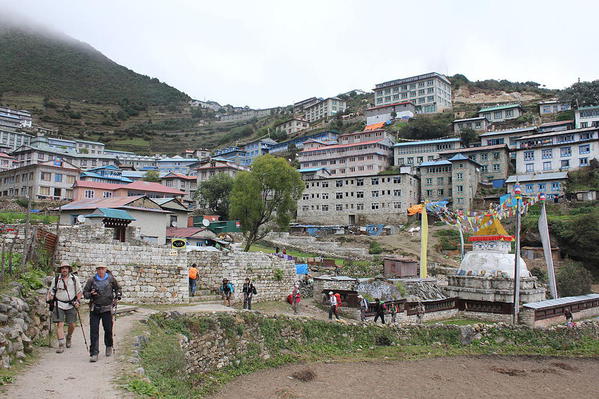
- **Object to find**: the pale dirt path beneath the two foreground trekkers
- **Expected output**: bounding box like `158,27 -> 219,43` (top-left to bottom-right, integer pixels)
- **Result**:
0,304 -> 234,399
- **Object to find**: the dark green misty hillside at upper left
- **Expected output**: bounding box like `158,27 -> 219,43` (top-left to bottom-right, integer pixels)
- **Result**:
0,19 -> 189,105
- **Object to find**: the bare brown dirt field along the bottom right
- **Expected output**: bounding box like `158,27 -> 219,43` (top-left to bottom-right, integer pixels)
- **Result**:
212,357 -> 599,399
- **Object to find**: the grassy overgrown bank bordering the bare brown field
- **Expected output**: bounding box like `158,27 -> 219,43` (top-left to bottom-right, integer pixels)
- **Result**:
135,313 -> 599,398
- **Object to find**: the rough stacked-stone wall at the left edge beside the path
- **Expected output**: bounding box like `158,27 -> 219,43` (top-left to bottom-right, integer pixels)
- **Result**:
0,283 -> 49,368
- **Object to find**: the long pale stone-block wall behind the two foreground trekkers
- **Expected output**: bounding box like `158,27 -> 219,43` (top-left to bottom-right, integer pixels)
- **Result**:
56,225 -> 296,303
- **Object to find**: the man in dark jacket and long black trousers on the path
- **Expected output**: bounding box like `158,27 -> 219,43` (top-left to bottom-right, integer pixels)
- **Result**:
83,266 -> 122,362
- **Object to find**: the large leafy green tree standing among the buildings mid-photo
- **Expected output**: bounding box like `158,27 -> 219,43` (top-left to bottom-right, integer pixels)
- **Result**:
229,155 -> 304,251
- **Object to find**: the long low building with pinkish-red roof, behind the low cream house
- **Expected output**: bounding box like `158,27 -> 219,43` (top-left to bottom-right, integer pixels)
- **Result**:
73,180 -> 185,201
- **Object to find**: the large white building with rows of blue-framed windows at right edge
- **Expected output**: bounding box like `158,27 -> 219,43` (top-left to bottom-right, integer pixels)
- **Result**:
516,127 -> 599,175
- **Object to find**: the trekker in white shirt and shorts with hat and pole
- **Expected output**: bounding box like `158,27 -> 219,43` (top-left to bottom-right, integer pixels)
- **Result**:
46,263 -> 83,353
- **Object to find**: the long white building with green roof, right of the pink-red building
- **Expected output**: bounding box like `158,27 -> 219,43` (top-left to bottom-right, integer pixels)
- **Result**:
393,137 -> 462,166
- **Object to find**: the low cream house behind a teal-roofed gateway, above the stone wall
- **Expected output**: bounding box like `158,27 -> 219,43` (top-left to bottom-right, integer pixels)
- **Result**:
60,195 -> 171,245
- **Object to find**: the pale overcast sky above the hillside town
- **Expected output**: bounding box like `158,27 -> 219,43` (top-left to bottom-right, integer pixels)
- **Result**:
0,0 -> 599,108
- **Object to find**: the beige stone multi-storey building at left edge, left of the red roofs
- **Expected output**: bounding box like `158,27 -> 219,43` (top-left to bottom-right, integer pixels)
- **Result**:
0,160 -> 81,200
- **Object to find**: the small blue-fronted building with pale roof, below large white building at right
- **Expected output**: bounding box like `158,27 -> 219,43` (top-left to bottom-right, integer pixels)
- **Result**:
505,172 -> 568,199
